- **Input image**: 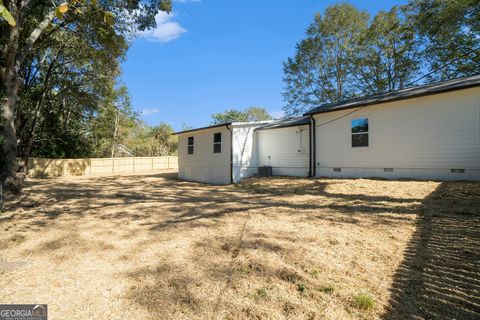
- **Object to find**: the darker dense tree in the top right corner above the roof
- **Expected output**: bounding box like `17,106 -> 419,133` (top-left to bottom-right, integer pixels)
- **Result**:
405,0 -> 480,82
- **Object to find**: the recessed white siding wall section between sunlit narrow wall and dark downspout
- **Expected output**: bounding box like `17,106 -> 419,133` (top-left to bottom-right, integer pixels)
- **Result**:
256,125 -> 309,176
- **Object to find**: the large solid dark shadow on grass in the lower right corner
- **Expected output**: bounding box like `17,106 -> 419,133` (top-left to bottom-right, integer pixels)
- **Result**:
383,182 -> 480,320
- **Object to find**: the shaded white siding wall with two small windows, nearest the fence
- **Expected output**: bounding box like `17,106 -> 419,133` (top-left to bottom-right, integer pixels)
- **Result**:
178,127 -> 230,184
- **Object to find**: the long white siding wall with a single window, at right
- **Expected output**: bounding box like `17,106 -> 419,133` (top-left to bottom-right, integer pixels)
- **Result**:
314,87 -> 480,180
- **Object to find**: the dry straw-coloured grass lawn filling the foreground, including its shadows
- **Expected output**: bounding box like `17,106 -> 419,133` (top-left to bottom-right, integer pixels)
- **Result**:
0,173 -> 480,319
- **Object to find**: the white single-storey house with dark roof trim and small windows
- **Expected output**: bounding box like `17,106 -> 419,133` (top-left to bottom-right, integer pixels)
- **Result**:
177,76 -> 480,184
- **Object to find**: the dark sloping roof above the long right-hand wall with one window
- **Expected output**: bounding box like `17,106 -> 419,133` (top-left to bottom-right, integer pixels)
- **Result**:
304,75 -> 480,116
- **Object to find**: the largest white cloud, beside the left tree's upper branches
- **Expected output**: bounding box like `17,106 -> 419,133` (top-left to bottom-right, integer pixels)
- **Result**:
138,11 -> 187,43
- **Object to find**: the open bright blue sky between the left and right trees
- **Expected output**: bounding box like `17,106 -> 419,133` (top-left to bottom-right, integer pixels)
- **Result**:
122,0 -> 406,130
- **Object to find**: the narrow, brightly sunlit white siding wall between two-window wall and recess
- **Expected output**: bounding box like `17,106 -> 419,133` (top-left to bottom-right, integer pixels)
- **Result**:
232,124 -> 258,183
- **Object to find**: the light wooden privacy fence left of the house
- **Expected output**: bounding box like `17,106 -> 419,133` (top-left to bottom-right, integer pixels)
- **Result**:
28,156 -> 178,177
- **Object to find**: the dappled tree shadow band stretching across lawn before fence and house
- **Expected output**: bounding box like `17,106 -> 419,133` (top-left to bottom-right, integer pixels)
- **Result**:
0,173 -> 421,230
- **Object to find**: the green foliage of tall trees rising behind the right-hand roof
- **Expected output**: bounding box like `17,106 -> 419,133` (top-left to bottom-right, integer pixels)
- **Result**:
283,0 -> 480,116
